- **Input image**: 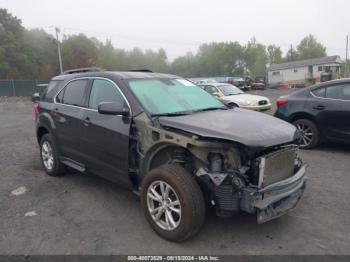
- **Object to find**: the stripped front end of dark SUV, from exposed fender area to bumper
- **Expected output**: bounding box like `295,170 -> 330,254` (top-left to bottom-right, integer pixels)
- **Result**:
130,112 -> 306,223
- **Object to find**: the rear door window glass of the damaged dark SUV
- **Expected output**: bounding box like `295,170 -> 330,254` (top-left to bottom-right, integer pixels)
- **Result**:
62,80 -> 87,107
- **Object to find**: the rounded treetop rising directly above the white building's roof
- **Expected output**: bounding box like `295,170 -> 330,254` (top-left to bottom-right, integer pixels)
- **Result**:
297,34 -> 327,59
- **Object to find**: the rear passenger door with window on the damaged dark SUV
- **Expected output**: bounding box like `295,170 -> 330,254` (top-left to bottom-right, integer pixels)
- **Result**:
51,79 -> 88,162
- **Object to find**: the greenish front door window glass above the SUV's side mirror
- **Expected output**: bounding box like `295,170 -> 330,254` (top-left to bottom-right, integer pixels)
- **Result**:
89,79 -> 124,109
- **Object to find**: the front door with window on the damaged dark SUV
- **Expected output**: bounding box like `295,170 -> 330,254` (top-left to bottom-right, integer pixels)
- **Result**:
83,79 -> 131,186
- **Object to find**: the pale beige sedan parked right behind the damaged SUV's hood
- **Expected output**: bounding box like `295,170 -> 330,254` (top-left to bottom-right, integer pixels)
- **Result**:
201,83 -> 271,111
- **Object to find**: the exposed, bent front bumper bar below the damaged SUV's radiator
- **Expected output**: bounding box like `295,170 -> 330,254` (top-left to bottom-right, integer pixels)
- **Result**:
240,165 -> 306,224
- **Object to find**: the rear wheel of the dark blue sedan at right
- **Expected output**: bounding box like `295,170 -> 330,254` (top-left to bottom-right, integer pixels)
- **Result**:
293,119 -> 320,149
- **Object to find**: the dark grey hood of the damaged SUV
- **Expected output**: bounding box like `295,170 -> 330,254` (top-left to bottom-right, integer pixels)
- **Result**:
159,108 -> 296,147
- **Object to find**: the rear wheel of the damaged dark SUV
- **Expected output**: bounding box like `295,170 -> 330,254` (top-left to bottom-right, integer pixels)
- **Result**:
40,134 -> 66,176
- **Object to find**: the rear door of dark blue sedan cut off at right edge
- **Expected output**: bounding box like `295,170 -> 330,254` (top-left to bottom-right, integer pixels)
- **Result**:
309,83 -> 350,141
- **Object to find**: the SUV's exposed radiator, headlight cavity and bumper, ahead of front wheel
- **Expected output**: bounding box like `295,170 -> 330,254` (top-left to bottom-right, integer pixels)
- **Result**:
196,145 -> 306,223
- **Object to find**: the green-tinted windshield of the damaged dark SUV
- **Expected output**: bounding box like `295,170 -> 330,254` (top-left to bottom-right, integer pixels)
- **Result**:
128,79 -> 224,115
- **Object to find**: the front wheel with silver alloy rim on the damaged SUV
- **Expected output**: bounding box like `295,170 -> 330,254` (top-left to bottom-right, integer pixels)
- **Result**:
141,165 -> 205,242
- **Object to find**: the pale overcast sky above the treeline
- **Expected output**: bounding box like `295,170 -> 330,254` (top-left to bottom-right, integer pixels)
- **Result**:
0,0 -> 350,60
